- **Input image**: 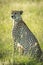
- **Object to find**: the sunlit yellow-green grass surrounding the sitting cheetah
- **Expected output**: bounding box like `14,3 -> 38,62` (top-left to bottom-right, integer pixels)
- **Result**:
0,0 -> 43,65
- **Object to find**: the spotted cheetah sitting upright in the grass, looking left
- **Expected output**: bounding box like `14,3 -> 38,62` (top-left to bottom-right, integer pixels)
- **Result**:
11,10 -> 42,59
